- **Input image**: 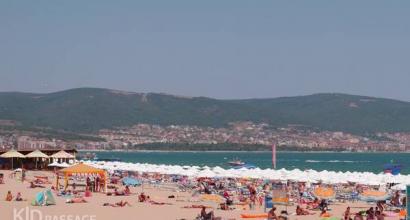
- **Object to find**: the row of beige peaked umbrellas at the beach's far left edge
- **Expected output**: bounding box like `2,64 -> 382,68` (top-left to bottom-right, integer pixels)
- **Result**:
0,149 -> 75,169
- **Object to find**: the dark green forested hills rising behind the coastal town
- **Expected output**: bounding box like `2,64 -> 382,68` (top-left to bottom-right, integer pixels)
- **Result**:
0,88 -> 410,133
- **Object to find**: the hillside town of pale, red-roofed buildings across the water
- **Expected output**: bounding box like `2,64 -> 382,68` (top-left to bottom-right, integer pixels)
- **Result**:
0,122 -> 410,152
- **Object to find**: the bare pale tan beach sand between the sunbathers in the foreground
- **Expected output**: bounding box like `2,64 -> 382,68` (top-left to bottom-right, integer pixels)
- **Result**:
0,170 -> 382,220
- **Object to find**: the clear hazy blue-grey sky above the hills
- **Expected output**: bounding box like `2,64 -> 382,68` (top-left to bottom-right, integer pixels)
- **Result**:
0,0 -> 410,101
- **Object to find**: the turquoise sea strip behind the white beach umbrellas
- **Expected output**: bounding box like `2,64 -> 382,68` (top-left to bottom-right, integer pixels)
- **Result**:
84,152 -> 410,174
